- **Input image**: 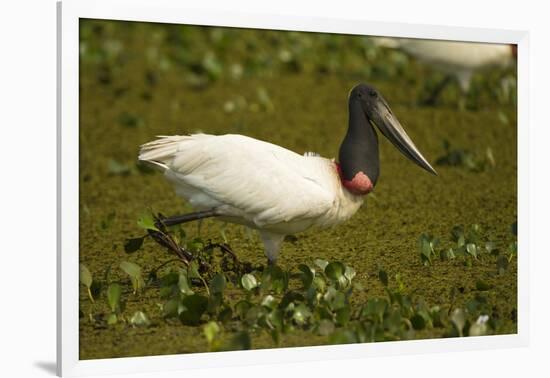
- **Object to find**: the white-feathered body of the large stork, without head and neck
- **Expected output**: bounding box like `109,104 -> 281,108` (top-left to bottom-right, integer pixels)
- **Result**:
139,134 -> 363,261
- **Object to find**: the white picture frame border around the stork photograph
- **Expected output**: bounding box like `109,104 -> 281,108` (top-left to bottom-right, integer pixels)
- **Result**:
57,0 -> 529,376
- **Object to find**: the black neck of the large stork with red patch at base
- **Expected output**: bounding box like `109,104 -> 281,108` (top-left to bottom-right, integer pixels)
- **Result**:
338,99 -> 380,195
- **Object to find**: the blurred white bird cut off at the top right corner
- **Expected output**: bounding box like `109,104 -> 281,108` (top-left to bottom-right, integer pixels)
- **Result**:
370,37 -> 517,102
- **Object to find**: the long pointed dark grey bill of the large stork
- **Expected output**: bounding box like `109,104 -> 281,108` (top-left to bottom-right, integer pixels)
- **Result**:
374,98 -> 437,175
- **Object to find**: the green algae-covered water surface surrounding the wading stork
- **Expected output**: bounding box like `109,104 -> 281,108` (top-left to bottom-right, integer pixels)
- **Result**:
79,20 -> 521,359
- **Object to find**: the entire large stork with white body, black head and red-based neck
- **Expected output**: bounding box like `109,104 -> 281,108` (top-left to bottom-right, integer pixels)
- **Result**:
139,84 -> 436,264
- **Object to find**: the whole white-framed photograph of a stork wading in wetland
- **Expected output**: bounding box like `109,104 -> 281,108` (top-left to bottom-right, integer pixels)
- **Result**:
58,0 -> 529,376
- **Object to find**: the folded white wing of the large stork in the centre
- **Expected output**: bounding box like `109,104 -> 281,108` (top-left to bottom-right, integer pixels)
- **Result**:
140,134 -> 334,227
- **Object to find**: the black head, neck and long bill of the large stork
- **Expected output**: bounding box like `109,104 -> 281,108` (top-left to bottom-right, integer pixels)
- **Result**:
339,84 -> 437,195
